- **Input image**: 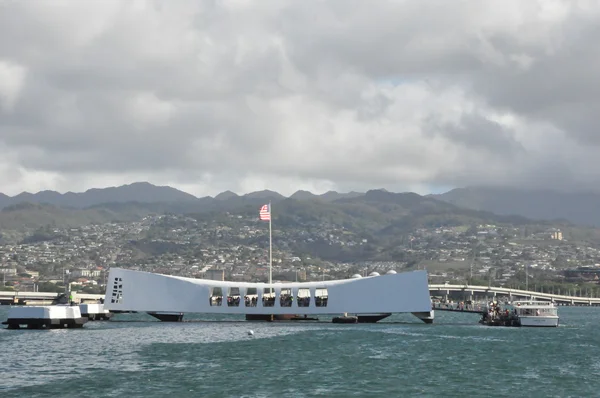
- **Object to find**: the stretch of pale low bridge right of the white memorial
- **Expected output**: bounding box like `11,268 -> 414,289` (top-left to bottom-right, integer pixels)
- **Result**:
429,284 -> 600,305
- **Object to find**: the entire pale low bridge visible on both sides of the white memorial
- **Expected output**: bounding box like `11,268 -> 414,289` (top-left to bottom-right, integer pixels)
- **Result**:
0,284 -> 600,305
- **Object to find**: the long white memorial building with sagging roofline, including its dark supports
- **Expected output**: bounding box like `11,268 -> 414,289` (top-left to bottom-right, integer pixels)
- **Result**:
104,268 -> 433,323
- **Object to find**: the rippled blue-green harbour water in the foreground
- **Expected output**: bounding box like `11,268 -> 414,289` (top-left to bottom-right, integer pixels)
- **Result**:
0,307 -> 600,398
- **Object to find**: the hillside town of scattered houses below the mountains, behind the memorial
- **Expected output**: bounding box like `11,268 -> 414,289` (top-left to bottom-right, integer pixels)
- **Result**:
0,214 -> 600,292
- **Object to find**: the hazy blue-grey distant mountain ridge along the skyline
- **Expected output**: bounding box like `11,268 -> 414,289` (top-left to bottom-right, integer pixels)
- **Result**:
0,182 -> 600,226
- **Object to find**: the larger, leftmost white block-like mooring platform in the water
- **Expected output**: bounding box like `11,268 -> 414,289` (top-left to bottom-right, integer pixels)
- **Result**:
2,305 -> 88,329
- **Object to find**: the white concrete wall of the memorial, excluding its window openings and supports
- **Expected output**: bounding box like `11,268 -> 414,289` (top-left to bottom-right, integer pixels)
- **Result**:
104,268 -> 431,315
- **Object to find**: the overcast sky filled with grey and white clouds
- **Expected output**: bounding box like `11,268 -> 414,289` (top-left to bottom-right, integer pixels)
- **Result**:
0,0 -> 600,196
